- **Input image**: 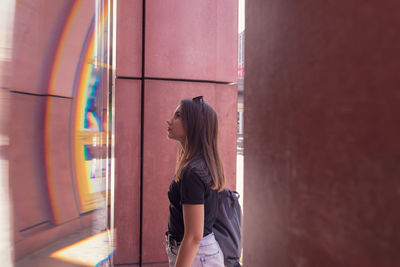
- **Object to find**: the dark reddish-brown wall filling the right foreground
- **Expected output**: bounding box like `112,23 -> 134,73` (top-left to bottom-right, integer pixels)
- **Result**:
243,0 -> 400,267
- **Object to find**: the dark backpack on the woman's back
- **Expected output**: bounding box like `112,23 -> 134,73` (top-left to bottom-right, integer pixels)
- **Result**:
213,189 -> 242,267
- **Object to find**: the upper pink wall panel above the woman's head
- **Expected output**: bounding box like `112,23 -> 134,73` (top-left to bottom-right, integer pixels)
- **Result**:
145,0 -> 237,82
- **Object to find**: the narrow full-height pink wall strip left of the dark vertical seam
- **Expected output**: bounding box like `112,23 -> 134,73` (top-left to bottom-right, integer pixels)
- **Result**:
114,0 -> 143,266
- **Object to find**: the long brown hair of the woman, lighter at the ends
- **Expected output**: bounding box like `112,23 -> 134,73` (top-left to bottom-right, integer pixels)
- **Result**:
175,97 -> 225,191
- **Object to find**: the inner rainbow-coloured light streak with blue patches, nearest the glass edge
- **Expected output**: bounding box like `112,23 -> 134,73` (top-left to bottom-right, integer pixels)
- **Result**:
73,0 -> 108,211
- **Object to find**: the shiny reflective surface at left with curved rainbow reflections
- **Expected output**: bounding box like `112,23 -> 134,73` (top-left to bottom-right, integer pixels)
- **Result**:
0,0 -> 114,266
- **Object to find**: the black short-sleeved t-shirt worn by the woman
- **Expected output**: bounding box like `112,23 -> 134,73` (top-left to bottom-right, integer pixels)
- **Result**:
168,156 -> 218,242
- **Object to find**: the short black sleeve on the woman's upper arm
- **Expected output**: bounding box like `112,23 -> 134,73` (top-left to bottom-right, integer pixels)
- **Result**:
181,171 -> 206,204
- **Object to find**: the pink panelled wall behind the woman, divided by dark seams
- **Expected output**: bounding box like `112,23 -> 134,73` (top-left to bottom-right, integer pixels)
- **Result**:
114,0 -> 237,266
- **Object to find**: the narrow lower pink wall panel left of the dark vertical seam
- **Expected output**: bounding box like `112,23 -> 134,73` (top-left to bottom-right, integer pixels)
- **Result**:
114,79 -> 141,264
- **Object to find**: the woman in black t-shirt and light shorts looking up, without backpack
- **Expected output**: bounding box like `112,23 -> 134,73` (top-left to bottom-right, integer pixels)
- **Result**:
166,96 -> 225,267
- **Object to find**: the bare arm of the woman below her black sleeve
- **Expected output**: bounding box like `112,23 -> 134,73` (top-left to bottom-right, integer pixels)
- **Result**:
175,204 -> 204,267
